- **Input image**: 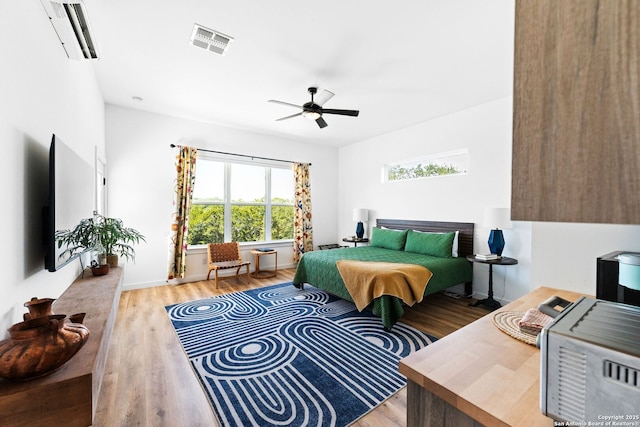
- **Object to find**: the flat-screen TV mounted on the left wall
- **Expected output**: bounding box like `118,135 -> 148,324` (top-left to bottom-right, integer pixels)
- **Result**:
44,135 -> 95,271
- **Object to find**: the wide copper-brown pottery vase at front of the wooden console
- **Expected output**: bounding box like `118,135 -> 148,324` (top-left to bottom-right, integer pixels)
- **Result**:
0,314 -> 89,381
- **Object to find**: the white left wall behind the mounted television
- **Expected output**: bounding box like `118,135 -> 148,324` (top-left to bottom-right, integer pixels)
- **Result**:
0,1 -> 104,337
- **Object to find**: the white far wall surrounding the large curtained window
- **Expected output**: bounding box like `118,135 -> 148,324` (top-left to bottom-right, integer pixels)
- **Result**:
106,105 -> 338,288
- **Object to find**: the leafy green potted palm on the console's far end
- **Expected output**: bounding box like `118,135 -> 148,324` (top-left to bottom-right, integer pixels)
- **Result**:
56,214 -> 146,267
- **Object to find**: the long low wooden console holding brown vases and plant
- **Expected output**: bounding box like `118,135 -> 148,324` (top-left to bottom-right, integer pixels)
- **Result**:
0,267 -> 122,427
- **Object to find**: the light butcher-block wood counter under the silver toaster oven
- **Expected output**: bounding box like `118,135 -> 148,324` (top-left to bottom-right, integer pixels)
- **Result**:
399,287 -> 592,427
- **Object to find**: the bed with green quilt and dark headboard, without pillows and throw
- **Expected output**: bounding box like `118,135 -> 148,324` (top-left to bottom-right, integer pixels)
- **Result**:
293,219 -> 474,329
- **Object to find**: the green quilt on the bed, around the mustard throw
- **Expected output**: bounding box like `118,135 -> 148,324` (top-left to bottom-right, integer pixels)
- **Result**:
293,246 -> 473,329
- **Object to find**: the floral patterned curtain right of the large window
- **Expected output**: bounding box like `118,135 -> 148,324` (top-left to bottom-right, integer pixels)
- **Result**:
293,163 -> 313,262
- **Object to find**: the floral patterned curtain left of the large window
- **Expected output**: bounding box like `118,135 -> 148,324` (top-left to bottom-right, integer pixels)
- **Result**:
168,147 -> 198,279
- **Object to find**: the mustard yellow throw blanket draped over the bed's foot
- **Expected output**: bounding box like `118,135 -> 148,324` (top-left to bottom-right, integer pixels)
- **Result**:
336,260 -> 433,311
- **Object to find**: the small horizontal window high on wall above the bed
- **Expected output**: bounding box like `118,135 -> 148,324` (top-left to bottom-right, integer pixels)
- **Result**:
382,149 -> 468,182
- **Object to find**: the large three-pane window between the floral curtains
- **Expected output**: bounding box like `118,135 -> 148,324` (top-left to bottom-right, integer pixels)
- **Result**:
188,155 -> 294,245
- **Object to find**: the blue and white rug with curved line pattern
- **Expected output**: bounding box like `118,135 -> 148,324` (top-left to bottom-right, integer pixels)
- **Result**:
166,283 -> 435,426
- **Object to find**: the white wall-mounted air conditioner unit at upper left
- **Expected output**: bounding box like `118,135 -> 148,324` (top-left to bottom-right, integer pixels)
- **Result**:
40,0 -> 98,60
